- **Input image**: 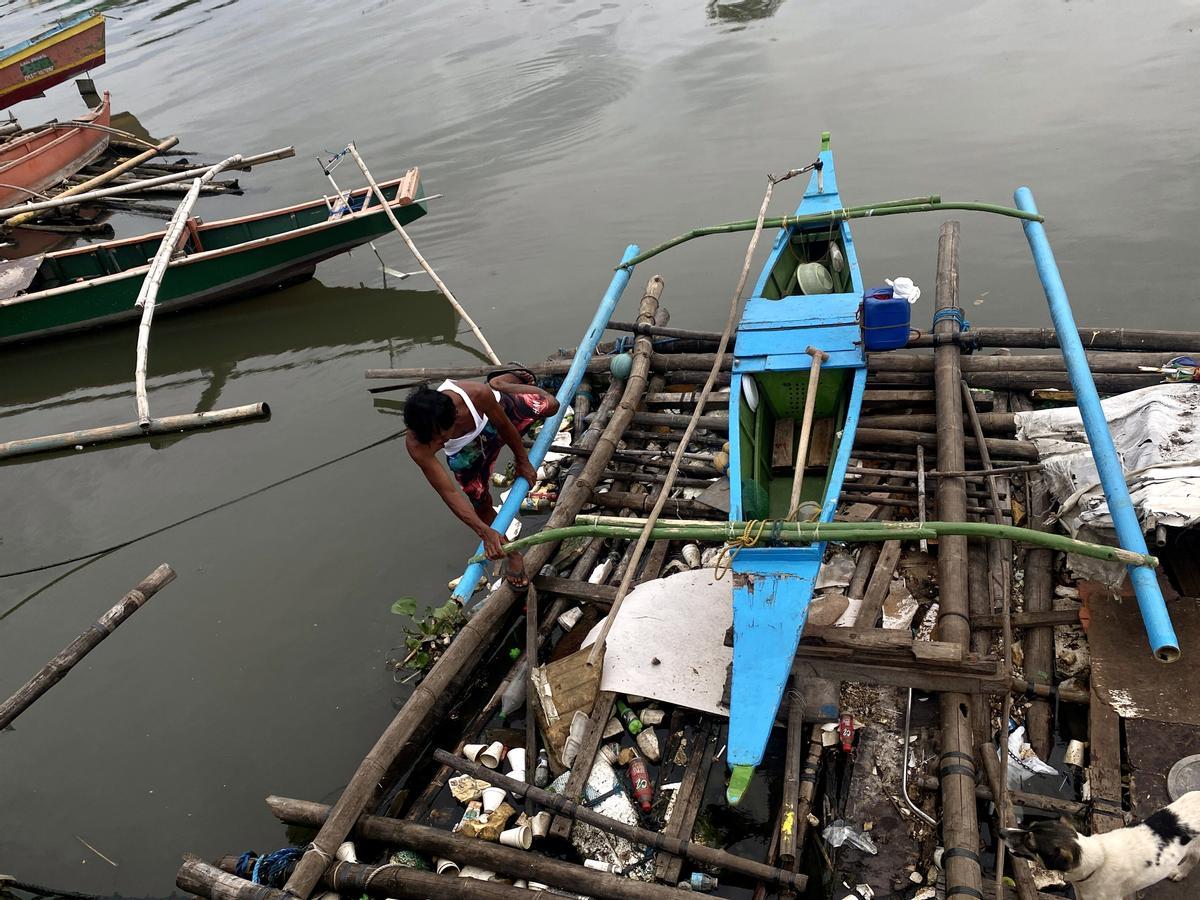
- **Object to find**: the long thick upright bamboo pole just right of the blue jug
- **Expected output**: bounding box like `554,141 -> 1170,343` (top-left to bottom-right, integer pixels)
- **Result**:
934,221 -> 983,896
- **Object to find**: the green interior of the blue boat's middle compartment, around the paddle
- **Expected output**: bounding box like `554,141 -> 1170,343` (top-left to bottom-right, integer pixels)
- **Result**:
738,368 -> 853,520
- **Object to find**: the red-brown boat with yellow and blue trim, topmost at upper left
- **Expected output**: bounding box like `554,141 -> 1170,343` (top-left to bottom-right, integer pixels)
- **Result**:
0,12 -> 104,109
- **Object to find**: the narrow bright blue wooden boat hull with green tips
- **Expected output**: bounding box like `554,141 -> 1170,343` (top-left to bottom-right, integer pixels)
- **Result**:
727,133 -> 866,803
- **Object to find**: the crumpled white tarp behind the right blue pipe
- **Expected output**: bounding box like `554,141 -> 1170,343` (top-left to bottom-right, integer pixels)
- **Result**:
1015,383 -> 1200,581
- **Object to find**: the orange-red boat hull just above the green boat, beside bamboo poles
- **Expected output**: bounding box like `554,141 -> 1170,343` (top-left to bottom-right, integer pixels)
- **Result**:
0,91 -> 110,206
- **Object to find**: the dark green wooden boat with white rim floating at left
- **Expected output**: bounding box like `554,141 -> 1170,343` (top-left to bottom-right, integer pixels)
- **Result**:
0,168 -> 426,344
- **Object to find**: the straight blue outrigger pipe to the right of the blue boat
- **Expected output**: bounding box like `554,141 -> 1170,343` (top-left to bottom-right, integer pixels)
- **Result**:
1014,187 -> 1180,662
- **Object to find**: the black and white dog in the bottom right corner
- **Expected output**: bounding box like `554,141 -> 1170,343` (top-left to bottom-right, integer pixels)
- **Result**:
1004,791 -> 1200,900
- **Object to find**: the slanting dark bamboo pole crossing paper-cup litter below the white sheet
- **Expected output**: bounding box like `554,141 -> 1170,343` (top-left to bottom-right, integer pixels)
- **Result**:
433,750 -> 809,890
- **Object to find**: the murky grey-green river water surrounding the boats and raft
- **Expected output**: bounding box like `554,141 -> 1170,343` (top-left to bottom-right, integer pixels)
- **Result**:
0,0 -> 1200,896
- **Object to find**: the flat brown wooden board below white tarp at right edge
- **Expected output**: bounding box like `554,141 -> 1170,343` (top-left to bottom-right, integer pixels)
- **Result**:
1087,595 -> 1200,726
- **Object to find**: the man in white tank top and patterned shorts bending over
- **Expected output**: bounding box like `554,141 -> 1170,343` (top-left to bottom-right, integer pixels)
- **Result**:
404,370 -> 558,590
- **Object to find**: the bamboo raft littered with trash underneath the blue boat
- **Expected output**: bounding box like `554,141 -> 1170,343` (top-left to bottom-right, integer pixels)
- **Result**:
4,139 -> 1200,900
